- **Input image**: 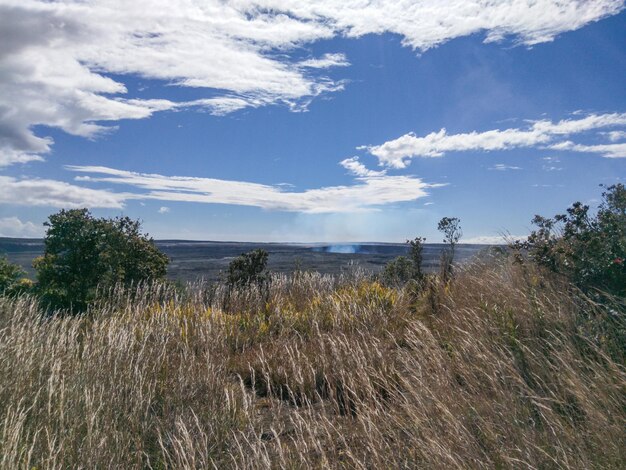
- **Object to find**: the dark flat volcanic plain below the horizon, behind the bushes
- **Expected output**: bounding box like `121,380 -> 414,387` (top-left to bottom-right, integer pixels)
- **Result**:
0,237 -> 488,281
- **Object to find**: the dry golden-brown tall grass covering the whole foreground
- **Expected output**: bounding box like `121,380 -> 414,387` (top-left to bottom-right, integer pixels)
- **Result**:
0,258 -> 626,469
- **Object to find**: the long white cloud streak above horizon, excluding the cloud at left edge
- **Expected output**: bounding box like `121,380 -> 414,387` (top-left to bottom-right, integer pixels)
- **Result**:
67,166 -> 441,213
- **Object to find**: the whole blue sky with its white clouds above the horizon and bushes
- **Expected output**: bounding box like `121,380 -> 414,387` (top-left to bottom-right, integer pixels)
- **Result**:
0,0 -> 626,242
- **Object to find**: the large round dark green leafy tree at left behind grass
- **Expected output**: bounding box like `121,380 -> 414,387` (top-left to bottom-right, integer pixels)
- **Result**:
34,209 -> 169,311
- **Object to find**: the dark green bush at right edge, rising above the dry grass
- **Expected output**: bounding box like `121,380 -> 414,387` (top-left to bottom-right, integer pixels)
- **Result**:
526,184 -> 626,295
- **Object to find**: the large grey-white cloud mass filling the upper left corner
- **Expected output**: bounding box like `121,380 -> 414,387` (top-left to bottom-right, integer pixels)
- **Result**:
0,0 -> 341,165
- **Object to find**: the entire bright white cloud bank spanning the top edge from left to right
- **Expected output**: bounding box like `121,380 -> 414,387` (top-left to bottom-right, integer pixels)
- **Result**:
0,0 -> 623,166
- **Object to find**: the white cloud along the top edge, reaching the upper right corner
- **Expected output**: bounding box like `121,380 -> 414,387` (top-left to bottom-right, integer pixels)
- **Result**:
258,0 -> 623,50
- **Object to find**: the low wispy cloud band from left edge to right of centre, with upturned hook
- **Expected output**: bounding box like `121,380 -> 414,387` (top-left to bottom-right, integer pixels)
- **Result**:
0,158 -> 438,214
